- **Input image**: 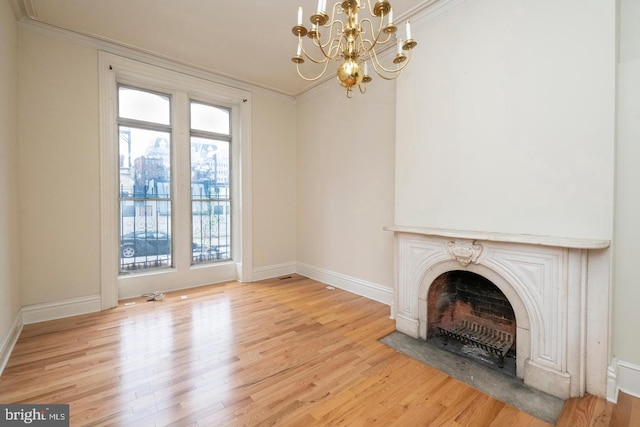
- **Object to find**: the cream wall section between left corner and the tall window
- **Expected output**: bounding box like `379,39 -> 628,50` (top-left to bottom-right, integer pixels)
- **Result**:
19,29 -> 100,305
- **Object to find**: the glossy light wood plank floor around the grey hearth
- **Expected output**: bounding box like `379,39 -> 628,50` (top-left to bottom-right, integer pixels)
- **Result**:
0,275 -> 640,427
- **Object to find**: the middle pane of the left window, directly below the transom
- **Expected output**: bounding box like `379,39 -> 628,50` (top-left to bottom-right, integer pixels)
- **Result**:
120,126 -> 171,198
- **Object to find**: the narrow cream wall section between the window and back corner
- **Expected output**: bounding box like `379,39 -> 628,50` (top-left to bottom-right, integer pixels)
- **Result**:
251,95 -> 296,269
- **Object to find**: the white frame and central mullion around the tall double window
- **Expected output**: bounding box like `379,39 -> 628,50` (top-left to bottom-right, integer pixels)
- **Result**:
98,52 -> 252,310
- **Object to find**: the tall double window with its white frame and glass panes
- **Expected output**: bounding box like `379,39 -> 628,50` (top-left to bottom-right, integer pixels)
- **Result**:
99,52 -> 252,309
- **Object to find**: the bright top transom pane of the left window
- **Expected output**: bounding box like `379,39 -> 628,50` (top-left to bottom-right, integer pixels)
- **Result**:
118,87 -> 171,125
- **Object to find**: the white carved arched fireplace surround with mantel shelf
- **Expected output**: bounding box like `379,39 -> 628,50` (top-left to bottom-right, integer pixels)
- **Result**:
385,226 -> 611,399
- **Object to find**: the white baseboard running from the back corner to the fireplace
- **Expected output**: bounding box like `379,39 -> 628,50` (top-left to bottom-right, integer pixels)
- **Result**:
296,263 -> 393,305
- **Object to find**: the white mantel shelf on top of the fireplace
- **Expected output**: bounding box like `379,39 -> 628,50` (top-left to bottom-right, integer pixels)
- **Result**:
384,225 -> 611,249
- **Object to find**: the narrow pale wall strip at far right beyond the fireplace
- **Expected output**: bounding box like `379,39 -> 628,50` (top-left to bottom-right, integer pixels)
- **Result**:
613,0 -> 640,365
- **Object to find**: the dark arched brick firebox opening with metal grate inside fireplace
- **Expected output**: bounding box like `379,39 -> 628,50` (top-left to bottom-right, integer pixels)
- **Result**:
427,270 -> 517,376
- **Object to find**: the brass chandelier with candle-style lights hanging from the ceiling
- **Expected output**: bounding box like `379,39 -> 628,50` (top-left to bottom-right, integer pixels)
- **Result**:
291,0 -> 417,98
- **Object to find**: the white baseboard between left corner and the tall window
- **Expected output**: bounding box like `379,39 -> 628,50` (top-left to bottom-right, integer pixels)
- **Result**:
21,295 -> 102,325
